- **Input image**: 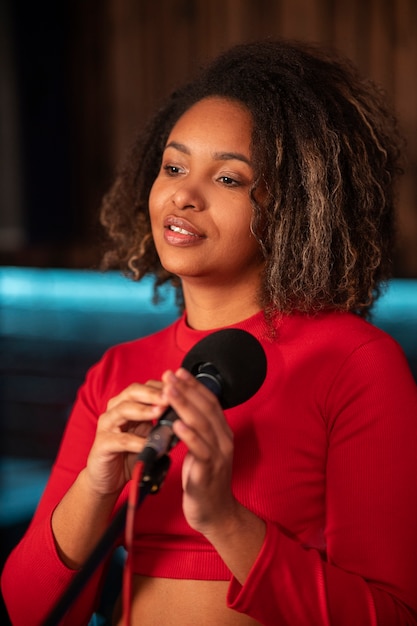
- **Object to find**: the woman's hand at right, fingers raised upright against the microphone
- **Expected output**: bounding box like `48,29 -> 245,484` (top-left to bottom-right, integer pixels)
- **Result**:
162,368 -> 238,536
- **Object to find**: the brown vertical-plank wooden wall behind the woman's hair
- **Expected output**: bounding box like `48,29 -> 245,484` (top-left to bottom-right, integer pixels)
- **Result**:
70,0 -> 417,276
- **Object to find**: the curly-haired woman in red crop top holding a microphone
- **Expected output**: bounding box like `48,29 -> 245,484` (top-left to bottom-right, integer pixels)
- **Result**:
2,41 -> 417,626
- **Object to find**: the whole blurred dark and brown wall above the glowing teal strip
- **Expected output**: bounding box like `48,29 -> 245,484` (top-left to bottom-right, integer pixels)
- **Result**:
0,0 -> 417,277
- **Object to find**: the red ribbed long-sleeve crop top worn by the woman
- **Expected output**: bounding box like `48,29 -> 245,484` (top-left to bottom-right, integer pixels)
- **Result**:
2,313 -> 417,626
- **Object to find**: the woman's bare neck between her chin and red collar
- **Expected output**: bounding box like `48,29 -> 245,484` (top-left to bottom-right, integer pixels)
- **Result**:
183,283 -> 262,330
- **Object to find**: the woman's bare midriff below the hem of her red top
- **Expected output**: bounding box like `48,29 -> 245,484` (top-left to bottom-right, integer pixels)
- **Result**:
113,575 -> 259,626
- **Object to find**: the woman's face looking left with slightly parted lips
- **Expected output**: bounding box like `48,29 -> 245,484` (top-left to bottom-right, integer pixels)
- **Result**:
149,97 -> 262,288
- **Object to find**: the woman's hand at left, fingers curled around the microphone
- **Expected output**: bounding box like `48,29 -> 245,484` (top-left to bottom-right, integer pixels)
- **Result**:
86,381 -> 167,495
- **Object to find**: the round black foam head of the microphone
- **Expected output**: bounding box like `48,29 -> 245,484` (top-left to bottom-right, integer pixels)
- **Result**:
182,328 -> 267,409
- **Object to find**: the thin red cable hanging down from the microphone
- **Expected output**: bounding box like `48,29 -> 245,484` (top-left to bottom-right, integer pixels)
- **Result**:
123,461 -> 144,626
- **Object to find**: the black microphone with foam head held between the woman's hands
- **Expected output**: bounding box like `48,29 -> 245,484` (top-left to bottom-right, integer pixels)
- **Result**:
138,328 -> 267,466
